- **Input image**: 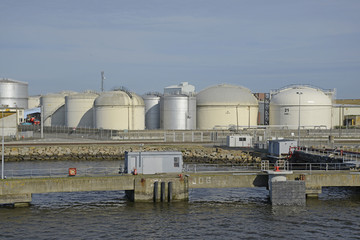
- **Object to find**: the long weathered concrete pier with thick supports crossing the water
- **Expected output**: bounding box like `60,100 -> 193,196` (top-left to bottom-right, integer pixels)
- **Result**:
0,171 -> 360,205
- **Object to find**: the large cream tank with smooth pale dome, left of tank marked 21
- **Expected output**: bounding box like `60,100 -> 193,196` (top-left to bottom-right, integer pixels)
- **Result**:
196,84 -> 259,129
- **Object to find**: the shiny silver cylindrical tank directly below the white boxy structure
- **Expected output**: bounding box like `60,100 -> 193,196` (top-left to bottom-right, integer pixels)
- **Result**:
160,95 -> 196,130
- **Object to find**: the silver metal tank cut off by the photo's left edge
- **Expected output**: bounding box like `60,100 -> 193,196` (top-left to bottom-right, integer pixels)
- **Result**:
0,78 -> 28,109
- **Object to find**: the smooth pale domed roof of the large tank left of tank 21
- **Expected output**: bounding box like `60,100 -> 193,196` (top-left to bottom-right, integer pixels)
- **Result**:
196,84 -> 258,106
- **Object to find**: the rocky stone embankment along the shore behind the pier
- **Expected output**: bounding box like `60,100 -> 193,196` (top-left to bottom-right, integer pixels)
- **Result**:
4,144 -> 261,164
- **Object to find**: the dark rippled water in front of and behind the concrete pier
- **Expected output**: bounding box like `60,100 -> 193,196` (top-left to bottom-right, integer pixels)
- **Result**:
0,161 -> 360,239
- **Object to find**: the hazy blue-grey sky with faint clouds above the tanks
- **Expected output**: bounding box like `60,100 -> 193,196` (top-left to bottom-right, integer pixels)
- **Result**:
0,0 -> 360,98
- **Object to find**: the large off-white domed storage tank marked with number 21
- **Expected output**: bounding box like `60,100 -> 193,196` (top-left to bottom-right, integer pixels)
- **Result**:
270,86 -> 332,129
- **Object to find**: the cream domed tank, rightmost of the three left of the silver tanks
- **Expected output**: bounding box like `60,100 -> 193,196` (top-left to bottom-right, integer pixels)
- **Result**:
94,90 -> 145,130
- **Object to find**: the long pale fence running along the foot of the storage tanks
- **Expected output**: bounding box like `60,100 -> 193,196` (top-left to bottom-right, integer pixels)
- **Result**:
18,125 -> 360,148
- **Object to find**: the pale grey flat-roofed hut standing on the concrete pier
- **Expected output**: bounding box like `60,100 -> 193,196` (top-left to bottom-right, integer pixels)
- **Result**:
124,152 -> 183,174
